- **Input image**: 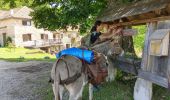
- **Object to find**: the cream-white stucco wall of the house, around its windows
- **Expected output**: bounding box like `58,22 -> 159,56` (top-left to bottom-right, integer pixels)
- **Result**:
0,18 -> 79,48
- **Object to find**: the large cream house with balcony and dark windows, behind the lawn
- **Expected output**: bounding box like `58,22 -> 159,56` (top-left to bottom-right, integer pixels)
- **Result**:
0,6 -> 81,51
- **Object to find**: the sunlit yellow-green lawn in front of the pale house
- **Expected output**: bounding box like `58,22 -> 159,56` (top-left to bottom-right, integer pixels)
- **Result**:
0,48 -> 56,62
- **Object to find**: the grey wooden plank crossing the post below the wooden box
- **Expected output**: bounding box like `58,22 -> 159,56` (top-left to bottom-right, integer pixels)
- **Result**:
138,70 -> 169,88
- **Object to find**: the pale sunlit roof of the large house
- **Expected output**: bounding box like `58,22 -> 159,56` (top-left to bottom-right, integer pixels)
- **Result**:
0,6 -> 33,19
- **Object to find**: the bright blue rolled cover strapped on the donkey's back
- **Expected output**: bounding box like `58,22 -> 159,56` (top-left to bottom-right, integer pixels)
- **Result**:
56,47 -> 94,63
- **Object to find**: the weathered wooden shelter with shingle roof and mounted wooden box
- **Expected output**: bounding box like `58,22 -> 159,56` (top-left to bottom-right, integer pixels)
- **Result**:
97,0 -> 170,100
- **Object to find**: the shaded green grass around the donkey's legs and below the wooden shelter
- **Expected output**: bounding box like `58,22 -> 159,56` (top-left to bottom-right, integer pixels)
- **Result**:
39,80 -> 170,100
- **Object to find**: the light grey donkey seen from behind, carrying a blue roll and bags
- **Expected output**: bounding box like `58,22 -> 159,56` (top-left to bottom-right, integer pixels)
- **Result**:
51,53 -> 108,100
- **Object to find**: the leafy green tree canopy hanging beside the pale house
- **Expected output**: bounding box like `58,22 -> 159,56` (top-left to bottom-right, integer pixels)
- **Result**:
31,0 -> 134,33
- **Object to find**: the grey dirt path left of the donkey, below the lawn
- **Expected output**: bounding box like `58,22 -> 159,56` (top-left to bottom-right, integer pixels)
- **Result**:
0,61 -> 52,100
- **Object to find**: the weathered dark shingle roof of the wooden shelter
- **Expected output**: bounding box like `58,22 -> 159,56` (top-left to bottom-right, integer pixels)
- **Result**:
97,0 -> 170,22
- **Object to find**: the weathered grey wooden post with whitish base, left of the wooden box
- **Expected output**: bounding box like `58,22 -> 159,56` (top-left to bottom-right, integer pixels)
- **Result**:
134,23 -> 156,100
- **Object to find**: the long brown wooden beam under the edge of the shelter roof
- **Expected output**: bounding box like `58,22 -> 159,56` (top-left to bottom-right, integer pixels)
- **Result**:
113,16 -> 170,26
